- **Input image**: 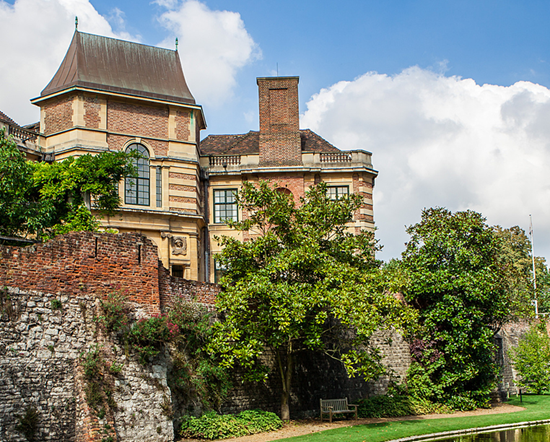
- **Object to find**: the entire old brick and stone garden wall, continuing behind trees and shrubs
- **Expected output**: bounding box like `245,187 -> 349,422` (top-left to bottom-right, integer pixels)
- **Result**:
0,232 -> 526,441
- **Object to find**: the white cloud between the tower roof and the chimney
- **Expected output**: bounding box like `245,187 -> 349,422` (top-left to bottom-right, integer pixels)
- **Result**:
156,0 -> 260,106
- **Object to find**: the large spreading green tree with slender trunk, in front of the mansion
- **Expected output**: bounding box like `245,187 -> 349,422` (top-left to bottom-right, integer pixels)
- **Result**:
212,182 -> 412,420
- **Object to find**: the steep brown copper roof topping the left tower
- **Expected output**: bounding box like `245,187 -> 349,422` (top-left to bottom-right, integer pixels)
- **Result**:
40,31 -> 195,104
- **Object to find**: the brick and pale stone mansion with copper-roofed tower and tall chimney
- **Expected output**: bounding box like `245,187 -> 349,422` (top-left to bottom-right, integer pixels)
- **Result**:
0,31 -> 377,282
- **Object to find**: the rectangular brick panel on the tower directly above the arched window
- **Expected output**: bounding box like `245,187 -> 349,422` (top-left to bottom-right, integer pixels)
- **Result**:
107,100 -> 168,139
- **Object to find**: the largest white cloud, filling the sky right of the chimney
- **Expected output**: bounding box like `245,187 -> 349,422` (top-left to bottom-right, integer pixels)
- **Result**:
301,67 -> 550,259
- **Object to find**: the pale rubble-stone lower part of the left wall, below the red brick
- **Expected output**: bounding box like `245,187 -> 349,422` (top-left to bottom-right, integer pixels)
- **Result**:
0,289 -> 174,442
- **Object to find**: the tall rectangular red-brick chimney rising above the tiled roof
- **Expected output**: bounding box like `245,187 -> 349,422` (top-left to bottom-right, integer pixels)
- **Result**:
256,77 -> 302,166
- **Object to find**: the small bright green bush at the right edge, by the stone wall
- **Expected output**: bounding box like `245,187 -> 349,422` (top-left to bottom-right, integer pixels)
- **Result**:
510,321 -> 550,394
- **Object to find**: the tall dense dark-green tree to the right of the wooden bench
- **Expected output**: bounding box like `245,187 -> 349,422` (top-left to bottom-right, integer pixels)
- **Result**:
402,208 -> 509,409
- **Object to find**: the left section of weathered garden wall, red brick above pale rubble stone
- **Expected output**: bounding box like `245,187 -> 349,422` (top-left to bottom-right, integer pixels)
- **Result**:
0,232 -> 217,442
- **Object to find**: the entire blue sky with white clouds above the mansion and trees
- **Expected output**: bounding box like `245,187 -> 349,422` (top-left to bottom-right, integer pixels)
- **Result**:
0,0 -> 550,260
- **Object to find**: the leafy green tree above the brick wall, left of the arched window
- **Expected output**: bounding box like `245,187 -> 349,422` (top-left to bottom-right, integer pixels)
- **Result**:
0,132 -> 136,242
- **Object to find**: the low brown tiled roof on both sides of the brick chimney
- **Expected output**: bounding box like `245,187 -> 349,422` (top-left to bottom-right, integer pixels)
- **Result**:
201,129 -> 340,155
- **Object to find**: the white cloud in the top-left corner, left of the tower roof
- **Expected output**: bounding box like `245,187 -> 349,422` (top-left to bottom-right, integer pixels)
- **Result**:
0,0 -> 133,124
